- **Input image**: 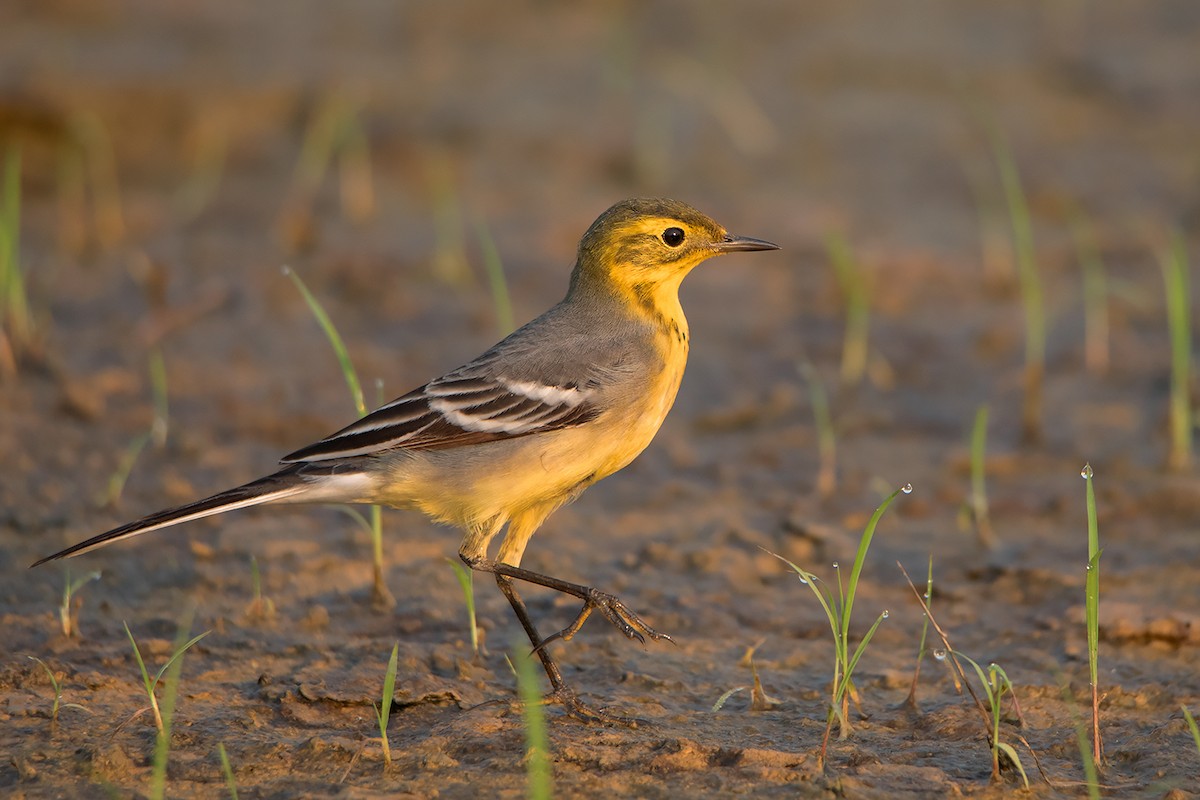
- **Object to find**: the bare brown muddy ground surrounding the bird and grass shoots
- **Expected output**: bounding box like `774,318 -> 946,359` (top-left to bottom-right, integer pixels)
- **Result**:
0,0 -> 1200,799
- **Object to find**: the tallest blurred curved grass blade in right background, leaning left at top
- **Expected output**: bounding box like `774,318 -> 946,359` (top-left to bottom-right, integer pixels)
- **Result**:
991,131 -> 1046,441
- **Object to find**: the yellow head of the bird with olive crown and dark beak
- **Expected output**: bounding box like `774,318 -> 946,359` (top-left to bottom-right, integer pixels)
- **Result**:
571,199 -> 779,317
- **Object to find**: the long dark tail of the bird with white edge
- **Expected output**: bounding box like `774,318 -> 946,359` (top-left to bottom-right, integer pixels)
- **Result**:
30,463 -> 365,567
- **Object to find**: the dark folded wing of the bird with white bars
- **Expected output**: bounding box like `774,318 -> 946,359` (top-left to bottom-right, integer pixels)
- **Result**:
281,354 -> 599,464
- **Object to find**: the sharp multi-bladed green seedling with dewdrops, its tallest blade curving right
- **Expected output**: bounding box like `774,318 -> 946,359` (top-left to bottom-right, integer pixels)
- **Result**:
768,485 -> 912,766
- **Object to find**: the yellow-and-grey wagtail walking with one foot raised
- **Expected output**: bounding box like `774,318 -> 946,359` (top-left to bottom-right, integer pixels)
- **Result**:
32,198 -> 779,721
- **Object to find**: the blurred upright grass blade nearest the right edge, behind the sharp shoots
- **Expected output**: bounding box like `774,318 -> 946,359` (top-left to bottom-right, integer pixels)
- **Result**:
1159,230 -> 1193,470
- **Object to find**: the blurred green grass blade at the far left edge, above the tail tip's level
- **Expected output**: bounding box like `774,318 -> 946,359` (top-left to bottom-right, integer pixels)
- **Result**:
0,149 -> 34,372
